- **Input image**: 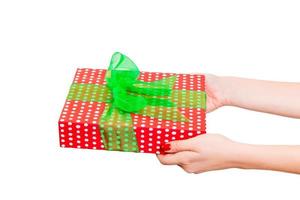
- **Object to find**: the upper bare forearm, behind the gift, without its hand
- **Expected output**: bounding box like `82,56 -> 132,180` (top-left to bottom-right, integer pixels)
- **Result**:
220,77 -> 300,118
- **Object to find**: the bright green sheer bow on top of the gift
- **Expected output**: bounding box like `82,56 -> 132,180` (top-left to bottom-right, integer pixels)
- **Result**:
106,52 -> 176,112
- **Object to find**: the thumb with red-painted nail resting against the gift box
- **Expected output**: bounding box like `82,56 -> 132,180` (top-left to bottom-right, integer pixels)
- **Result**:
161,139 -> 193,153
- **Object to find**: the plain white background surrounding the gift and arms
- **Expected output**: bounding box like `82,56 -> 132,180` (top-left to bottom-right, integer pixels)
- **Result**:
0,0 -> 300,200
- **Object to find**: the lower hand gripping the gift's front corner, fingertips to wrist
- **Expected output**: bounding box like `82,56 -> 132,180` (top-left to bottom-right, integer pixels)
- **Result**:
157,134 -> 240,173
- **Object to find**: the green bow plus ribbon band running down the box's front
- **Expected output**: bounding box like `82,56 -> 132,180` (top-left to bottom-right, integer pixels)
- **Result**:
100,52 -> 182,152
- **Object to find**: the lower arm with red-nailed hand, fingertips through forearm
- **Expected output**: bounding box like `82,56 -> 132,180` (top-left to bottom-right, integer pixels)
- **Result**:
157,134 -> 300,174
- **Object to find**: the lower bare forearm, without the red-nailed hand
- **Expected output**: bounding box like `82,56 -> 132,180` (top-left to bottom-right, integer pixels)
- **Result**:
233,144 -> 300,174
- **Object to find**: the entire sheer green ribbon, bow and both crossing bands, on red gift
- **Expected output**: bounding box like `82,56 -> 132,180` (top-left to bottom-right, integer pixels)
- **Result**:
68,52 -> 206,152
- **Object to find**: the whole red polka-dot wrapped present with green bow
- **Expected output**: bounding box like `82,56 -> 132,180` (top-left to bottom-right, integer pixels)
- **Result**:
58,53 -> 206,154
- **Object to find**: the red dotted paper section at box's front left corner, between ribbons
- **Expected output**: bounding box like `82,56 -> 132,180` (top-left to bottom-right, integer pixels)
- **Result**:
59,101 -> 105,149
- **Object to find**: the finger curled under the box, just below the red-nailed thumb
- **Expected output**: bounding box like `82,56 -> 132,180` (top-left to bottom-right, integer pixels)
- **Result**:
157,151 -> 191,165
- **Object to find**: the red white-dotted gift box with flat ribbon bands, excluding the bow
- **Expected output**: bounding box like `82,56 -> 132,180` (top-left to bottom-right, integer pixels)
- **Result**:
59,68 -> 206,154
